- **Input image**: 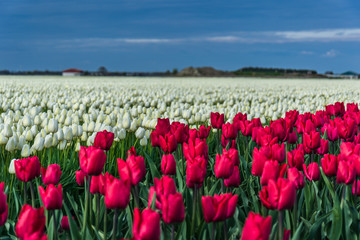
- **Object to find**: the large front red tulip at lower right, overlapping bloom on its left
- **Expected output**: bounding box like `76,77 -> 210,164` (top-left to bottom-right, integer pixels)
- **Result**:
268,178 -> 296,211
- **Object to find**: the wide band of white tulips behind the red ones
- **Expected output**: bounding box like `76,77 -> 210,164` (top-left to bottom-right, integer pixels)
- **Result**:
0,76 -> 360,153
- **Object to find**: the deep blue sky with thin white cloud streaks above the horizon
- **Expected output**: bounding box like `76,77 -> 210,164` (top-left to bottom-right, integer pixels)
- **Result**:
0,0 -> 360,72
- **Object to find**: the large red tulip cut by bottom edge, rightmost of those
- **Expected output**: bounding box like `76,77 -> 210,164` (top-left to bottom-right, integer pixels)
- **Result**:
241,212 -> 271,240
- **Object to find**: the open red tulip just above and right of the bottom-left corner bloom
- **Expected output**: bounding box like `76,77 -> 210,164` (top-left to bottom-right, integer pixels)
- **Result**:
39,184 -> 63,210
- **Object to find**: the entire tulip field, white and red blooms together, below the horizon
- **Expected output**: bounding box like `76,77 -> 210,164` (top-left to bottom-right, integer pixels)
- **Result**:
0,76 -> 360,240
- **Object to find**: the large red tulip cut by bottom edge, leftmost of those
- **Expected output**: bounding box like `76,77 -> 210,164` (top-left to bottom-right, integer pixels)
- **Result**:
15,204 -> 45,239
